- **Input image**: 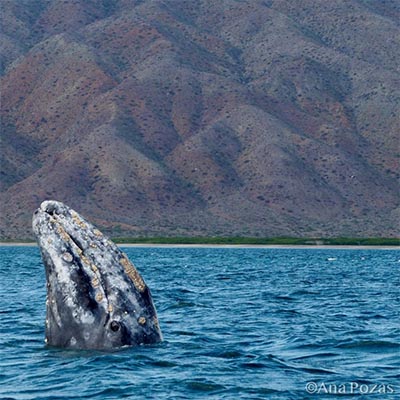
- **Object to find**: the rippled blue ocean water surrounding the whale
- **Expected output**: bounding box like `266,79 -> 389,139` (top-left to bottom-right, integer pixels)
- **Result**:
0,246 -> 400,400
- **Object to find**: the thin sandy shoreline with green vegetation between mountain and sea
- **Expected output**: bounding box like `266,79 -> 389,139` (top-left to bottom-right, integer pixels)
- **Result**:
0,242 -> 400,250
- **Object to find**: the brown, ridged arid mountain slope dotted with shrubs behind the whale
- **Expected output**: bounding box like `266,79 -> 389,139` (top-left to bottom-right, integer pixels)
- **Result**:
0,0 -> 400,239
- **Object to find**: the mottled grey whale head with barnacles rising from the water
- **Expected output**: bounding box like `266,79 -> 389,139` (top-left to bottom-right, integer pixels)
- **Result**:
32,201 -> 162,349
